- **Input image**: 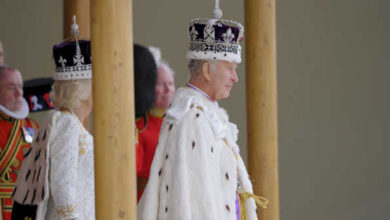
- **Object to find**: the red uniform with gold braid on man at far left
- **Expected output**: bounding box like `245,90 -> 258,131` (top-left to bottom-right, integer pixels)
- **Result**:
0,112 -> 38,220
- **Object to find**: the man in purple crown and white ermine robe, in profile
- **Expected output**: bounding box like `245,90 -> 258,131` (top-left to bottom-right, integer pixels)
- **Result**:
138,0 -> 268,220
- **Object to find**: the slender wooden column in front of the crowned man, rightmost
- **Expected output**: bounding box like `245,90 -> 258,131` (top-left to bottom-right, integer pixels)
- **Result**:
245,0 -> 279,220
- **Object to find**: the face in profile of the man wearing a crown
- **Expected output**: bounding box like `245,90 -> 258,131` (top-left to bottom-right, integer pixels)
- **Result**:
211,61 -> 238,101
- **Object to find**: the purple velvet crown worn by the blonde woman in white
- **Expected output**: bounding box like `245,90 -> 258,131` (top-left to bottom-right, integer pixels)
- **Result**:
53,16 -> 92,81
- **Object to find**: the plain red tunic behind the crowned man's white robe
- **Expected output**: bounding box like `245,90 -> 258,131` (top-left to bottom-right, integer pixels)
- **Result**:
136,108 -> 165,199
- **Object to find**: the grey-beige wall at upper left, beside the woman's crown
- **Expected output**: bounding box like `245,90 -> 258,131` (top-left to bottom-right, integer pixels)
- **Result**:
0,0 -> 63,79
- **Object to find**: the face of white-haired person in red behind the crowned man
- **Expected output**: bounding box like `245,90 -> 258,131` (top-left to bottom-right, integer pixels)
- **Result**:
154,67 -> 175,109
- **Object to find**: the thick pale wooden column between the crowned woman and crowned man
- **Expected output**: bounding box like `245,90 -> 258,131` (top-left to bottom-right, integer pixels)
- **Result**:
91,0 -> 136,220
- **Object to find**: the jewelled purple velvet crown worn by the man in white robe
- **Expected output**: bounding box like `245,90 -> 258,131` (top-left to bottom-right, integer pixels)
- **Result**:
187,0 -> 244,63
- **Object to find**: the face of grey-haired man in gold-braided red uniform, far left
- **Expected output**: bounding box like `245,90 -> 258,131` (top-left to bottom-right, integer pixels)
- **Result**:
0,70 -> 23,112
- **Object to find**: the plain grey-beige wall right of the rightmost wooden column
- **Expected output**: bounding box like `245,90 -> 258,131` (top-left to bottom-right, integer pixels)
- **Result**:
277,0 -> 390,220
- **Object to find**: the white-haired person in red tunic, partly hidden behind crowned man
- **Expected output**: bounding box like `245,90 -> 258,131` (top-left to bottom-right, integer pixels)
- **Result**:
136,47 -> 175,198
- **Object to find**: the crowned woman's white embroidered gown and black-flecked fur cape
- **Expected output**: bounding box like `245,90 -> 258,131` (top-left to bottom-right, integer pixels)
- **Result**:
12,111 -> 95,220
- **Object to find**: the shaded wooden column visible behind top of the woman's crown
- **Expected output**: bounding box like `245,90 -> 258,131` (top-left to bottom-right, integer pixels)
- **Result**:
64,0 -> 90,39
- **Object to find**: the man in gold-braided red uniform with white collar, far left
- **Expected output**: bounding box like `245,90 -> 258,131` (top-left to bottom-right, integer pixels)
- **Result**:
0,66 -> 38,220
